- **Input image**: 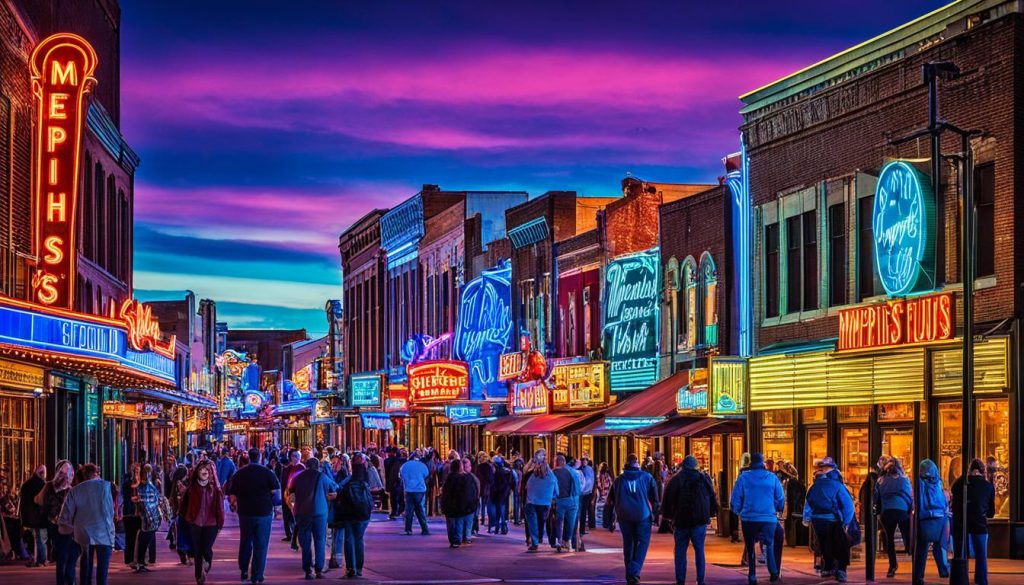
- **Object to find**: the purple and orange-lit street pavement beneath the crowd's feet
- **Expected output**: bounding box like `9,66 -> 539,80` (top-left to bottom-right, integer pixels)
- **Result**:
0,514 -> 1024,585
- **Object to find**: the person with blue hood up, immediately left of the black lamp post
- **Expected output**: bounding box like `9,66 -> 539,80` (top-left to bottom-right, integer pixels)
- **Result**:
912,459 -> 949,585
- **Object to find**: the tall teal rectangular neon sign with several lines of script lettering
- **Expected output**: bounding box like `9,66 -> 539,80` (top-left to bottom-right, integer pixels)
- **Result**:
604,248 -> 662,392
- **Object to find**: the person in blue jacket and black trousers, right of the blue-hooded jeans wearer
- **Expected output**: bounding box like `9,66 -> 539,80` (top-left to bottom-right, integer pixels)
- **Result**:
804,457 -> 855,583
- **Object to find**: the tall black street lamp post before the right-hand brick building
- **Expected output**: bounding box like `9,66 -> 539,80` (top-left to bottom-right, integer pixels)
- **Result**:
892,61 -> 981,585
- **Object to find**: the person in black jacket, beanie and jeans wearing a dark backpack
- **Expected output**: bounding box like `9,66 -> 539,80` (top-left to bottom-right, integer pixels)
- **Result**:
662,455 -> 718,585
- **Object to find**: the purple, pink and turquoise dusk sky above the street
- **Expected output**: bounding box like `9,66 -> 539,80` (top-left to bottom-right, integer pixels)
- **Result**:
121,0 -> 945,335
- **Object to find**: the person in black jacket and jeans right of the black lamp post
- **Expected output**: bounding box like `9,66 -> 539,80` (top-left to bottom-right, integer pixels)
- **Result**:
950,459 -> 995,585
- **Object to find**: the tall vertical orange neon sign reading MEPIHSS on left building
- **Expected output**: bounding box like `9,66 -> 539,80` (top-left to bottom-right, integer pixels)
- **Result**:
30,34 -> 97,309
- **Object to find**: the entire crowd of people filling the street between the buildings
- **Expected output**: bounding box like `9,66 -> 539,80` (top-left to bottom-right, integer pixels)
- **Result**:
0,443 -> 995,585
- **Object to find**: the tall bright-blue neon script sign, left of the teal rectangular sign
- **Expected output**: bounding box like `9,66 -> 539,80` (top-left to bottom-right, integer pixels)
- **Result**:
455,260 -> 512,401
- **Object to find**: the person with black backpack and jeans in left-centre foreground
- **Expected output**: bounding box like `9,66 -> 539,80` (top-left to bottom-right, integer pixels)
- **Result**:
334,453 -> 374,579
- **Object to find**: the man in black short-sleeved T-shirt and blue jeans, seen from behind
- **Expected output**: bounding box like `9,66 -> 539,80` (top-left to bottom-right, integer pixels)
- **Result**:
227,449 -> 281,583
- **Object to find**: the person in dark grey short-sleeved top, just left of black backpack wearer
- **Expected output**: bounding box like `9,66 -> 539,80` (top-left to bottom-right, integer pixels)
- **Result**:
289,457 -> 338,579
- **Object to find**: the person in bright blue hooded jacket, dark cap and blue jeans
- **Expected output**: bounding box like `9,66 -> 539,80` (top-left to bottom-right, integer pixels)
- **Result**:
729,453 -> 785,584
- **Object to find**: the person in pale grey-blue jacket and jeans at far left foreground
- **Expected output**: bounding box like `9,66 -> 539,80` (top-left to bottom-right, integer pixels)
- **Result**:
57,463 -> 117,585
